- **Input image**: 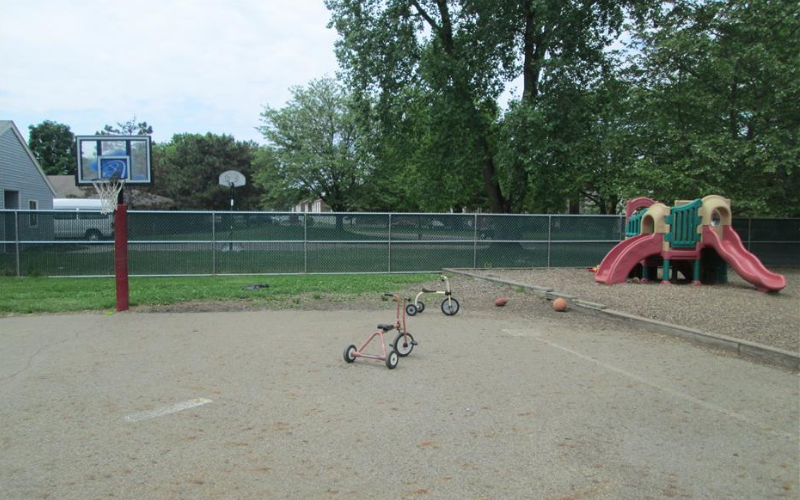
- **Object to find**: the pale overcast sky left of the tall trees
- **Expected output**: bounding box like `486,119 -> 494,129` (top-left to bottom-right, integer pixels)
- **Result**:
0,0 -> 337,143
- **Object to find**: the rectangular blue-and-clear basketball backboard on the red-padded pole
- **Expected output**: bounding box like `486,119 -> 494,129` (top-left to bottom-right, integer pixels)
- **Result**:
75,135 -> 153,186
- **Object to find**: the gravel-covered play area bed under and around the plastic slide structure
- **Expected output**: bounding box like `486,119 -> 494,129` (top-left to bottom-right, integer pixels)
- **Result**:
468,269 -> 800,352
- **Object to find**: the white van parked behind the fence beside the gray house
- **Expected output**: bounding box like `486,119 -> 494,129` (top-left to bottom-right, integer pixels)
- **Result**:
53,198 -> 114,241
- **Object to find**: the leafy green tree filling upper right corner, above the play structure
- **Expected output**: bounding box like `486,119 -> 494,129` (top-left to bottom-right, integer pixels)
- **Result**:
630,0 -> 800,216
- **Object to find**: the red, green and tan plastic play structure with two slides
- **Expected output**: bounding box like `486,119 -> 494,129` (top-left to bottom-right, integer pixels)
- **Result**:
595,195 -> 786,292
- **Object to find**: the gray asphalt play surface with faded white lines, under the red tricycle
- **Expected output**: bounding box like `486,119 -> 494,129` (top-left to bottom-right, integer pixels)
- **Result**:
0,304 -> 800,500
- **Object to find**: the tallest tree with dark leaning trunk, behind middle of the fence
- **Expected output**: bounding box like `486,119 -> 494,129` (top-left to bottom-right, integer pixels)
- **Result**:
327,0 -> 649,212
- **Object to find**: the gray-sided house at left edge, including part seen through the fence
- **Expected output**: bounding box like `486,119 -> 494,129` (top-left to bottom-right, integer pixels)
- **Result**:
0,120 -> 55,244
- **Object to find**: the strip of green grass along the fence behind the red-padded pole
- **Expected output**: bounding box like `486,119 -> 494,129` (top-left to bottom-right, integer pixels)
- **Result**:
0,274 -> 436,314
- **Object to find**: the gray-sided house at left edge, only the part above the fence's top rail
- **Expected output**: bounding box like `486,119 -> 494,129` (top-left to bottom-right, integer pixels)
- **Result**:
0,120 -> 56,210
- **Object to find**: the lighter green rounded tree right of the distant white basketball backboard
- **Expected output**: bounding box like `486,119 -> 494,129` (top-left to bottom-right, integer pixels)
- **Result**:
259,78 -> 369,212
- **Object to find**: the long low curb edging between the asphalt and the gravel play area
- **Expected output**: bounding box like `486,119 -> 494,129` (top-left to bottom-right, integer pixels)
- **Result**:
442,268 -> 800,371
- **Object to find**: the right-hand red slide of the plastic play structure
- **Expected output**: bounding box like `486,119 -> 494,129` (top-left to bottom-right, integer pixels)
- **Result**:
703,226 -> 786,292
